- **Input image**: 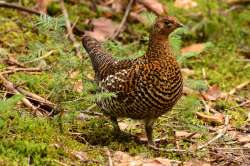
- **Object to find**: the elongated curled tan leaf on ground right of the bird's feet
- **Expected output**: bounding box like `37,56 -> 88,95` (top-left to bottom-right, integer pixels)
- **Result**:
196,112 -> 224,124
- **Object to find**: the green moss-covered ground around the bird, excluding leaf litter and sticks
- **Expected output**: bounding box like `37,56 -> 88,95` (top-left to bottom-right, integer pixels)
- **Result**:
0,0 -> 250,165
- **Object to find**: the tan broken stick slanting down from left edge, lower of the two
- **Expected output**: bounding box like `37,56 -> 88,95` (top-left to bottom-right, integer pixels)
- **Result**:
0,74 -> 42,116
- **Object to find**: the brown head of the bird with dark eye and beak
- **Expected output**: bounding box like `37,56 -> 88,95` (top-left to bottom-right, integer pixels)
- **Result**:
152,16 -> 183,36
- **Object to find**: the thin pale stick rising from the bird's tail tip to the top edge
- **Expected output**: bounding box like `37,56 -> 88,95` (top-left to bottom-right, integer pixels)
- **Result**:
60,0 -> 83,59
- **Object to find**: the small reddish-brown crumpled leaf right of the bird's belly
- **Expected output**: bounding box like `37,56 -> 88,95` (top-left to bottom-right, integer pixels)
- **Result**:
202,85 -> 223,101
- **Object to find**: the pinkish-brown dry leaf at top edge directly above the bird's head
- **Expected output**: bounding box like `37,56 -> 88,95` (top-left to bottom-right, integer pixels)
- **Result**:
139,0 -> 167,15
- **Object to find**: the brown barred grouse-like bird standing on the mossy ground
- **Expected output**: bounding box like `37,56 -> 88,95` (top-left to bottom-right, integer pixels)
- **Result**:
82,16 -> 183,145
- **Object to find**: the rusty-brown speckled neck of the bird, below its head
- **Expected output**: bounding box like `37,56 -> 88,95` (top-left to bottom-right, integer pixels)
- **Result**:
145,34 -> 173,60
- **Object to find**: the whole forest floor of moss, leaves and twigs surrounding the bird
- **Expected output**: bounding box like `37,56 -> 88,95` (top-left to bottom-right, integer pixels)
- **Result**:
0,0 -> 250,166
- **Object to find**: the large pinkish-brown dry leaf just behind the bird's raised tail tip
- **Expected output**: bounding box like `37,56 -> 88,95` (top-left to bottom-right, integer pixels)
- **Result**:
86,17 -> 118,41
